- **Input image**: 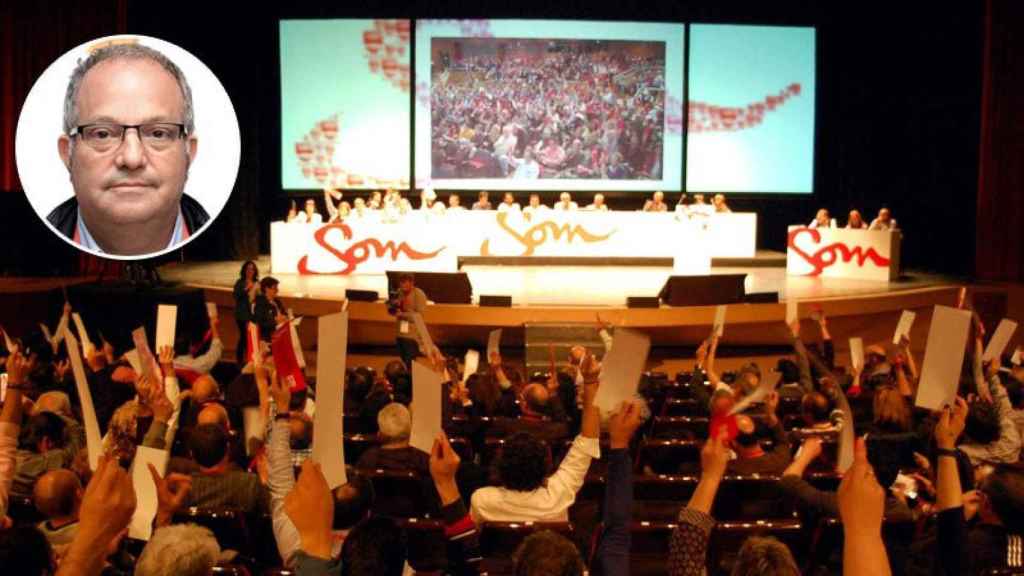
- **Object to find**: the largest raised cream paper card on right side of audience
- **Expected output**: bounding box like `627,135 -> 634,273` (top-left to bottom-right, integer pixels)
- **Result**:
914,306 -> 971,410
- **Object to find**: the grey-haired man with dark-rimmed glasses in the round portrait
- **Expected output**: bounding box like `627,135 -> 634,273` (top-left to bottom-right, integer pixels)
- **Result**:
46,43 -> 210,256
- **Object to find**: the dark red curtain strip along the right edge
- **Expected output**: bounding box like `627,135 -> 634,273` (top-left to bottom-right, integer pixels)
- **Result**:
975,0 -> 1024,282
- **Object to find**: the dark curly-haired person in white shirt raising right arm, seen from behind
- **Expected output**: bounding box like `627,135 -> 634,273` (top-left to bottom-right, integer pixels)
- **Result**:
469,370 -> 601,524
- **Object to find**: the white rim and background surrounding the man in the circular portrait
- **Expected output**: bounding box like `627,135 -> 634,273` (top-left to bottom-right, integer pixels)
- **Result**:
14,34 -> 242,260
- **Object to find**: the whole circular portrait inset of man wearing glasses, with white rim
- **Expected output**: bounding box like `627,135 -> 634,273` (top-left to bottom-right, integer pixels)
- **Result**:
15,35 -> 241,259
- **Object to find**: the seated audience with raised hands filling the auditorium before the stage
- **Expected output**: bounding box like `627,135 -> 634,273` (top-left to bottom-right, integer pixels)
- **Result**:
0,270 -> 1024,576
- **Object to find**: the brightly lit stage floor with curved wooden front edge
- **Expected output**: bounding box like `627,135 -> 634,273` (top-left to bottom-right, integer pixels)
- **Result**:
160,252 -> 962,356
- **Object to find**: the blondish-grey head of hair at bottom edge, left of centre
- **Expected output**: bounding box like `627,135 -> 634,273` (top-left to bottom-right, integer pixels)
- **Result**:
135,524 -> 220,576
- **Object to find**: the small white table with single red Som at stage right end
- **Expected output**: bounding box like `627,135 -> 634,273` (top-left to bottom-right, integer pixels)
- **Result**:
785,225 -> 903,282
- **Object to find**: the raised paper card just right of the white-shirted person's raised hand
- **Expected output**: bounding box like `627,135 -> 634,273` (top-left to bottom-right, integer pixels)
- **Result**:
594,328 -> 650,413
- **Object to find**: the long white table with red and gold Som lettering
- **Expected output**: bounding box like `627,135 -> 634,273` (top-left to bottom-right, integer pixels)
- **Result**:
270,210 -> 757,275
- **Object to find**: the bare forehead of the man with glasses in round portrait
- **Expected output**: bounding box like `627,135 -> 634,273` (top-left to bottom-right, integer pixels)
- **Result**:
78,58 -> 184,123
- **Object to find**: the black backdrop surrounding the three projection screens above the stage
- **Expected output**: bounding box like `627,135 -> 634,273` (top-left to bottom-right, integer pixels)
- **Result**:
0,0 -> 1024,281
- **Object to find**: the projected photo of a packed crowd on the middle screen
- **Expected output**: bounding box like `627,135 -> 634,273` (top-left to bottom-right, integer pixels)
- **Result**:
430,38 -> 666,180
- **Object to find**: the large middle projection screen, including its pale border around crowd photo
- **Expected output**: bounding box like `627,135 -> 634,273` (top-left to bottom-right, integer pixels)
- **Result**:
415,20 -> 685,191
